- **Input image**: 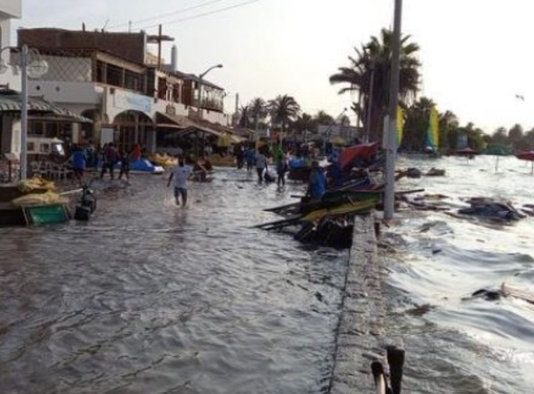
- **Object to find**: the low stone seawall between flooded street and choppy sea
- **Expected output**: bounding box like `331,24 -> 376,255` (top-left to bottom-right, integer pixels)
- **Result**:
330,215 -> 385,394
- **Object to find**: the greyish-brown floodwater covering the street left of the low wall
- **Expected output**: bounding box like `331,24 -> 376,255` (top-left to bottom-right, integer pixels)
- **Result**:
0,169 -> 348,394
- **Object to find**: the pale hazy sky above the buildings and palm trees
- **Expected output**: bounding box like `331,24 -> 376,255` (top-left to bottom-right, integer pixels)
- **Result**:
14,0 -> 534,133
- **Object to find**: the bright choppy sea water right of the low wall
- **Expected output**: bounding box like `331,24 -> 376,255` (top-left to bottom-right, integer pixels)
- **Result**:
385,156 -> 534,393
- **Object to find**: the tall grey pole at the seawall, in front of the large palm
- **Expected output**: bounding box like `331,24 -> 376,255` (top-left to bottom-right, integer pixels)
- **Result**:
384,0 -> 402,220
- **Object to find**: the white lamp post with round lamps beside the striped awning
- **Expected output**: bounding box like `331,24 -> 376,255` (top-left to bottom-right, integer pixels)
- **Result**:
0,45 -> 48,180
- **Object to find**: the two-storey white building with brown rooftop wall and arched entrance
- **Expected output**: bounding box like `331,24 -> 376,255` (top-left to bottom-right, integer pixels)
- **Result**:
18,29 -> 230,152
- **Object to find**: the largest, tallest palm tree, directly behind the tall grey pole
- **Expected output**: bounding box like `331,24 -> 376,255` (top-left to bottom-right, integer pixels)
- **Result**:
330,29 -> 421,141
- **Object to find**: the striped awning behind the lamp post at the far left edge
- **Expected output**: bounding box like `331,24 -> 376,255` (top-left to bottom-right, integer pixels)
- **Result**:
0,90 -> 93,123
